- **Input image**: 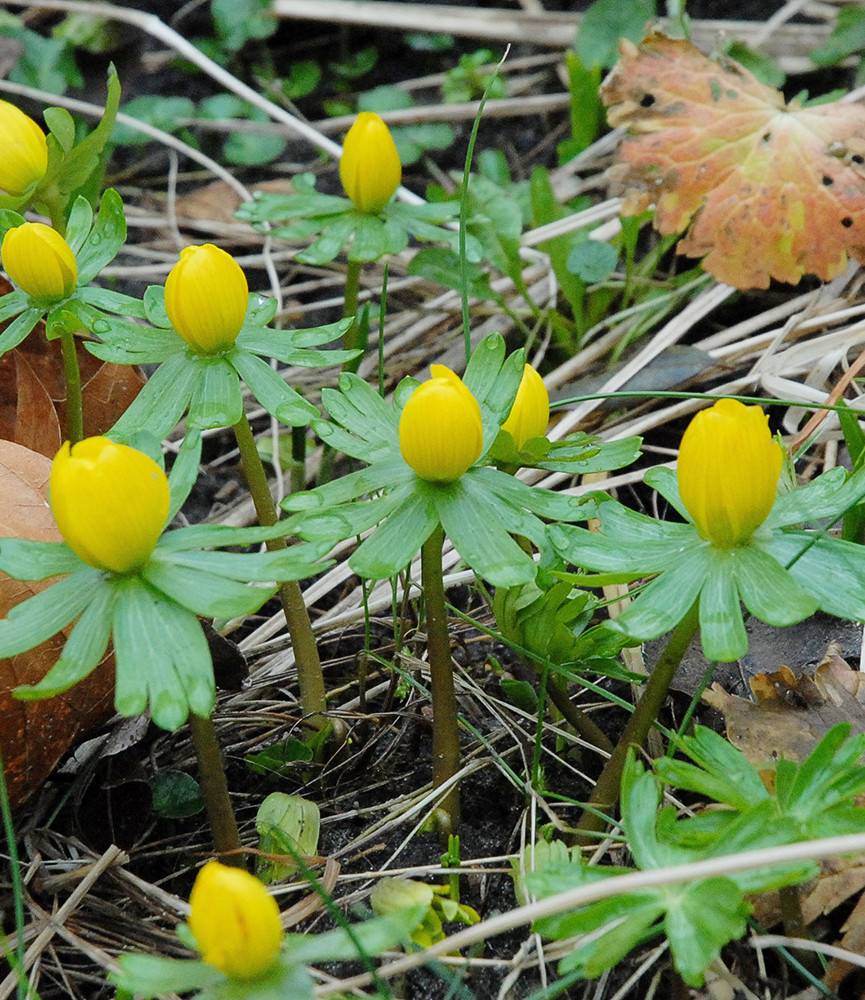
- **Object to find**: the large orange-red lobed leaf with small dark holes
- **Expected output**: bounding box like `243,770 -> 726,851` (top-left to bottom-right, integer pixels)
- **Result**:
602,33 -> 865,288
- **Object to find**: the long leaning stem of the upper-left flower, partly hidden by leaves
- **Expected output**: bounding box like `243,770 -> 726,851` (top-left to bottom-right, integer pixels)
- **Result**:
233,415 -> 327,729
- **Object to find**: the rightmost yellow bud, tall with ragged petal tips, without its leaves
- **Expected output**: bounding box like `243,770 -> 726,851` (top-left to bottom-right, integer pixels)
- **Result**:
677,399 -> 783,549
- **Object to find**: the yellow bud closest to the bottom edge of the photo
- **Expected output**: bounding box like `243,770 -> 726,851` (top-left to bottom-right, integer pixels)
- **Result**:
189,861 -> 282,979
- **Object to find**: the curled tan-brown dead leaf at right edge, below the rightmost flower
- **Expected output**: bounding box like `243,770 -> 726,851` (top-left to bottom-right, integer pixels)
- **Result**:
703,643 -> 865,770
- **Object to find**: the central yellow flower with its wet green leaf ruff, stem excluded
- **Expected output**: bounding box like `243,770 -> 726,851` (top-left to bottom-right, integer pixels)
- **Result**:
283,335 -> 595,587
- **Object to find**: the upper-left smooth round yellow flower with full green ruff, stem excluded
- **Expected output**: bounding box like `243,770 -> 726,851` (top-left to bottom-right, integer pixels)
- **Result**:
86,244 -> 358,440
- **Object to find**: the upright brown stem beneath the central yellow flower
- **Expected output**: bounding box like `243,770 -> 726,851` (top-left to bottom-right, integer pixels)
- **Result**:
421,527 -> 460,842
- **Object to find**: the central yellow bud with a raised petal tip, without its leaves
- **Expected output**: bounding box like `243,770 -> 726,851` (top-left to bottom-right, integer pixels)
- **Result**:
399,365 -> 484,483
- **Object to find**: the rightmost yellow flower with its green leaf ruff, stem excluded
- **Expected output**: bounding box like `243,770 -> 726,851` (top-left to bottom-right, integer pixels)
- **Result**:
549,400 -> 865,660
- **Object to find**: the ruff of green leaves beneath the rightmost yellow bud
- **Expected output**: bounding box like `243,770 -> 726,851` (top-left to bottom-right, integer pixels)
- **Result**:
550,469 -> 865,661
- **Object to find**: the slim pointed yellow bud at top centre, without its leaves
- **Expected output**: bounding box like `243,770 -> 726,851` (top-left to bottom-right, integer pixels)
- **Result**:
339,111 -> 402,215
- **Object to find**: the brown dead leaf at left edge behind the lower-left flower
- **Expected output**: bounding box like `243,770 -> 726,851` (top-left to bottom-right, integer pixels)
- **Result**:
0,441 -> 114,804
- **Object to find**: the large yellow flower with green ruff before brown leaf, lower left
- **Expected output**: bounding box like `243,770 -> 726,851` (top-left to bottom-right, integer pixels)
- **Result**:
0,432 -> 328,729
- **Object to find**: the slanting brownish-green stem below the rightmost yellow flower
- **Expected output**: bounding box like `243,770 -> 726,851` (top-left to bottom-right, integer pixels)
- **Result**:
577,602 -> 699,843
